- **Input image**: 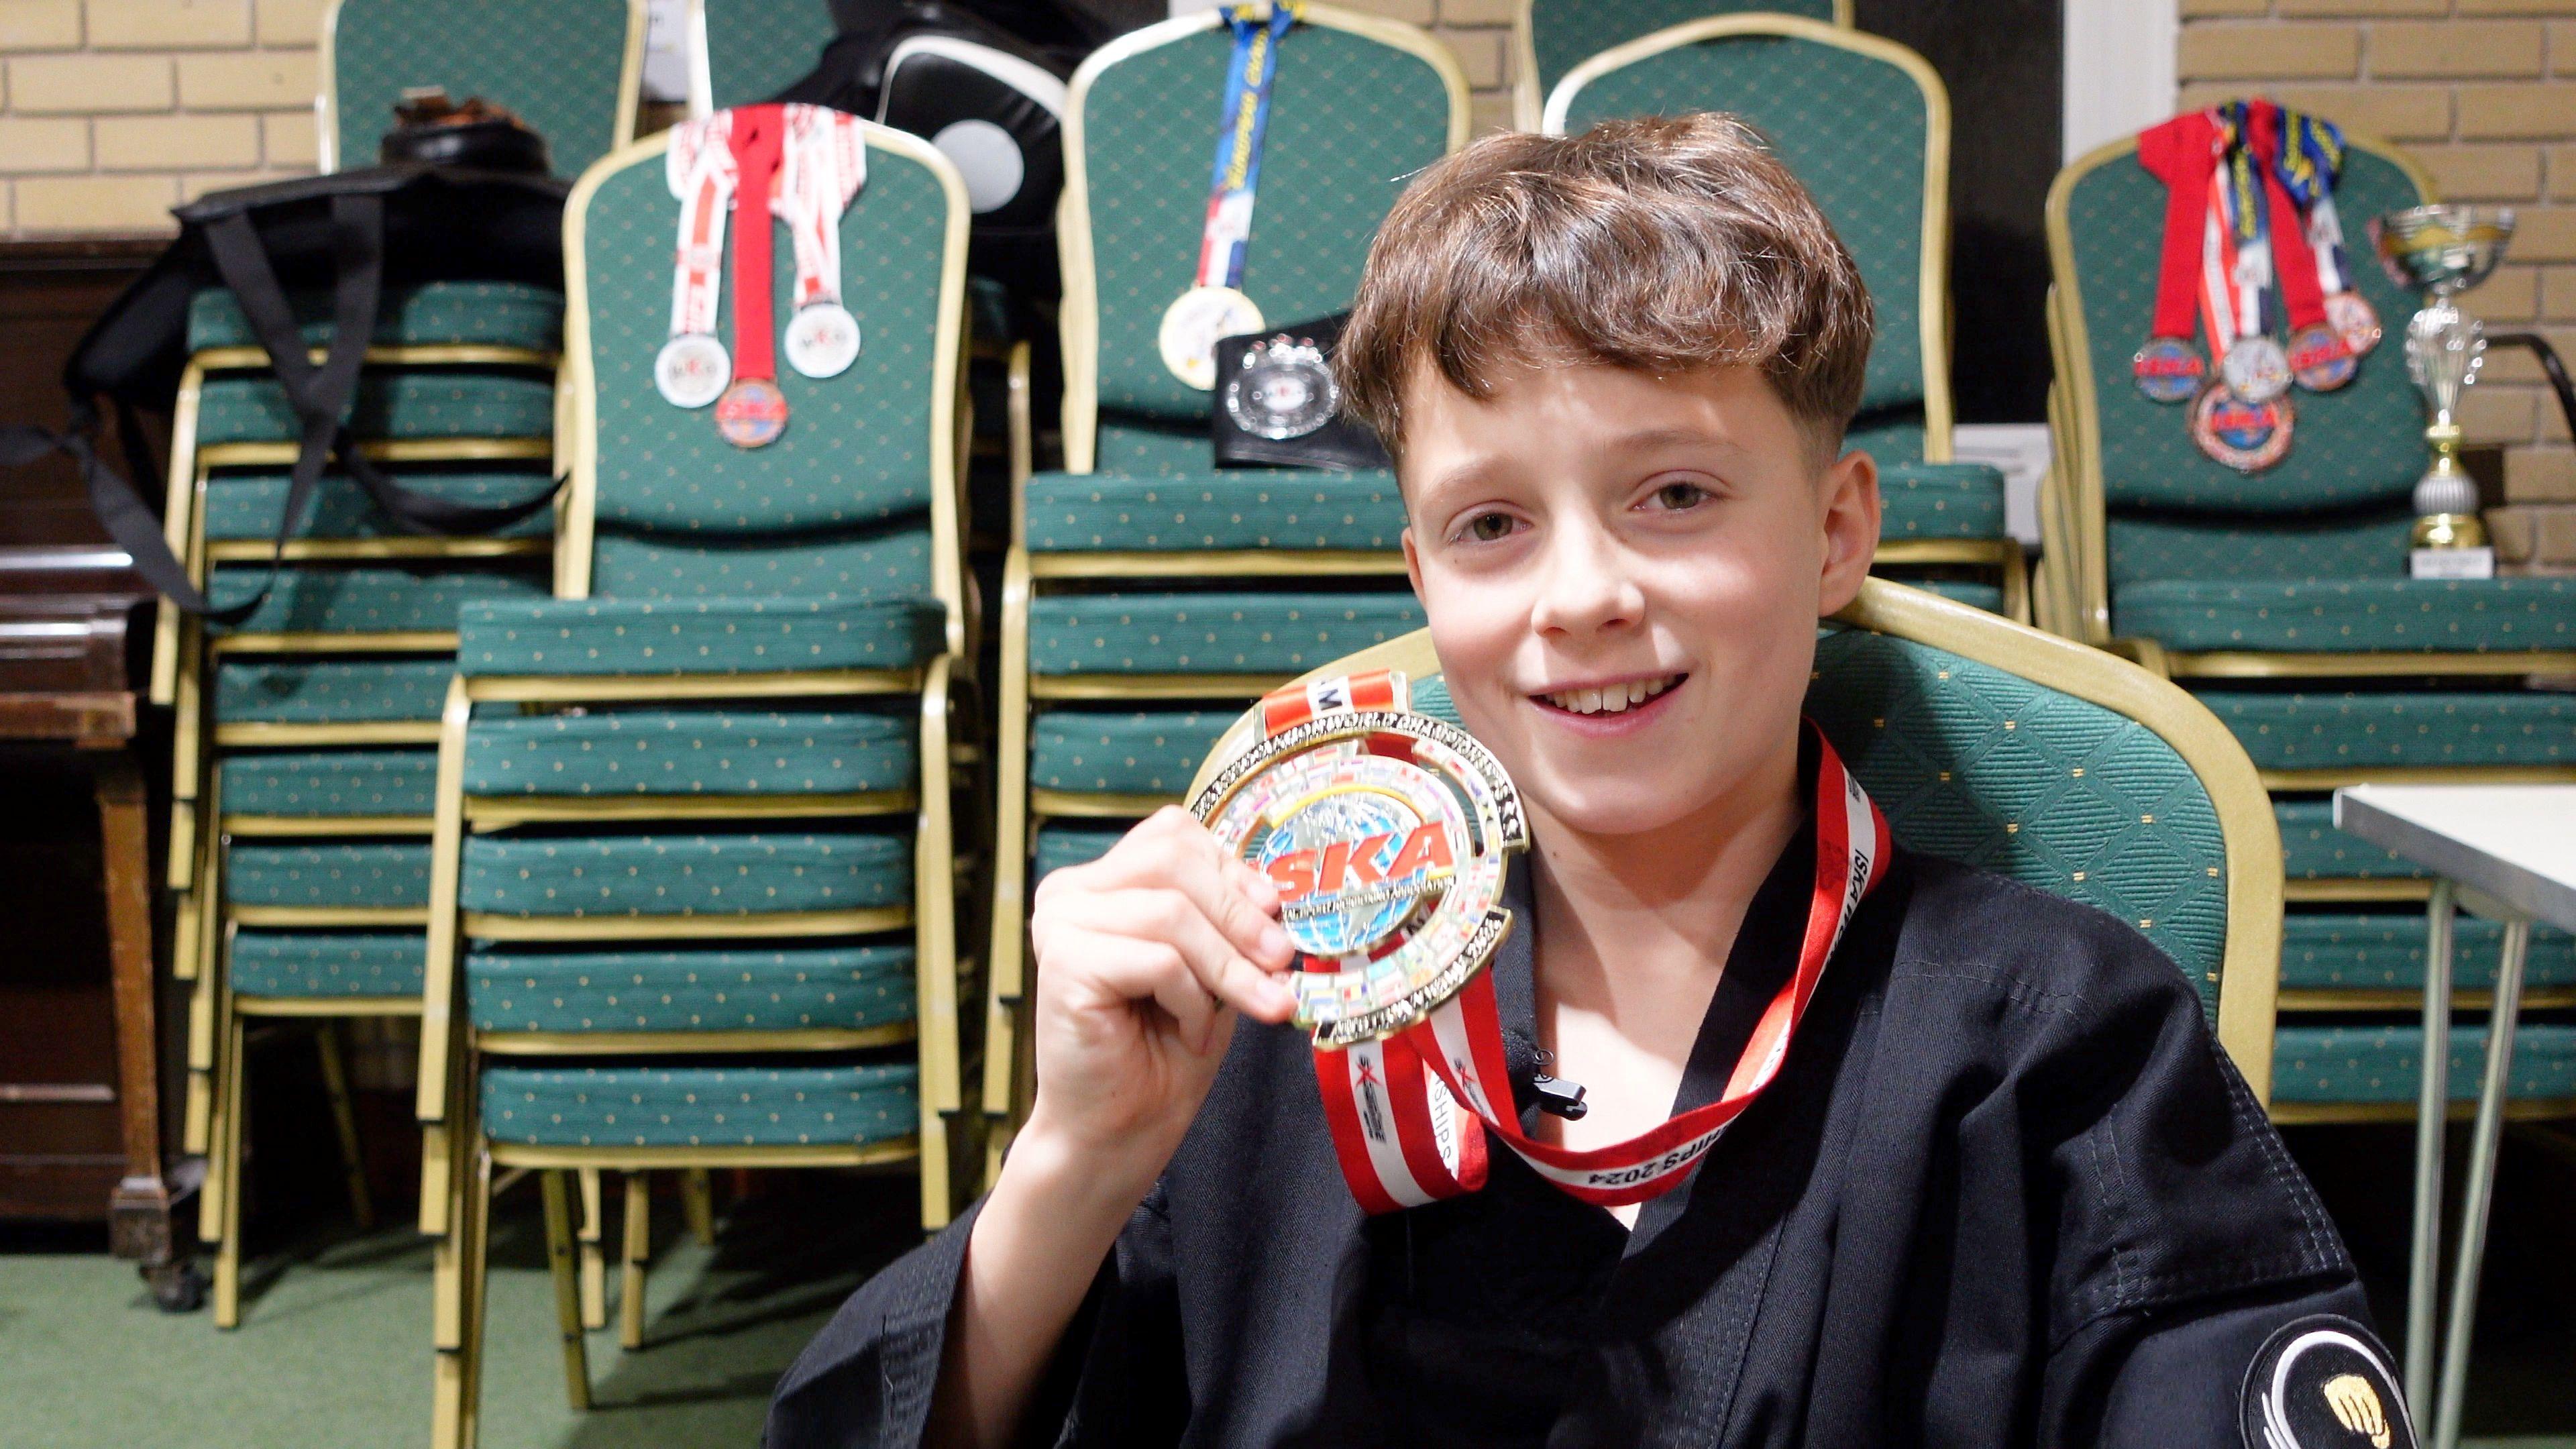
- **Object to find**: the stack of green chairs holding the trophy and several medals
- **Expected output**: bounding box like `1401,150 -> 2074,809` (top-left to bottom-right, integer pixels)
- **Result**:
2040,115 -> 2576,1122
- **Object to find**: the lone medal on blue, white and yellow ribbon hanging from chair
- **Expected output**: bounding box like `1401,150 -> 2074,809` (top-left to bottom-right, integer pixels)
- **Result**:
1154,0 -> 1298,392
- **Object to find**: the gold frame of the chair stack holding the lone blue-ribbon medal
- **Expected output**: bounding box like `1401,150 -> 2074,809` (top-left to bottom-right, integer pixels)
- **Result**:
984,5 -> 1471,1181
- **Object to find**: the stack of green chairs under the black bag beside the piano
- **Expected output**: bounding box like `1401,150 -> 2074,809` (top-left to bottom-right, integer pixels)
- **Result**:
154,284 -> 564,1328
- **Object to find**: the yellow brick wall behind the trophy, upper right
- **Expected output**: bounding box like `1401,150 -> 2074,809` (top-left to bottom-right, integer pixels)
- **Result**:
2177,0 -> 2576,518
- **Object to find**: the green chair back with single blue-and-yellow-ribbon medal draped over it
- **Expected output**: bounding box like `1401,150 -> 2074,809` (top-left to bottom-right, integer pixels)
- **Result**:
1061,5 -> 1466,472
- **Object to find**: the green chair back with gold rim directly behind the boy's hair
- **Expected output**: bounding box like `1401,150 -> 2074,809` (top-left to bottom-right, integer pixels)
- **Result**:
1546,15 -> 1950,445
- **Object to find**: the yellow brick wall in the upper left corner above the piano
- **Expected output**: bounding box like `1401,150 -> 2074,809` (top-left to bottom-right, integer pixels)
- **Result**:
0,0 -> 322,237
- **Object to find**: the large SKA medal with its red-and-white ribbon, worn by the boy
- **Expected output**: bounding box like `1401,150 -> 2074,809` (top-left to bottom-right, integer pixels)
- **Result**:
1190,670 -> 1891,1212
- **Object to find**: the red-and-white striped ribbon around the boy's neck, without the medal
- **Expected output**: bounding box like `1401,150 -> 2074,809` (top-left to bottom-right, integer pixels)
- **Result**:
1263,670 -> 1891,1212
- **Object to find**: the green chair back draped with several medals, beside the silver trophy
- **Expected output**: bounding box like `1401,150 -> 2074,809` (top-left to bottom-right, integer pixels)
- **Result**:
2048,123 -> 2429,521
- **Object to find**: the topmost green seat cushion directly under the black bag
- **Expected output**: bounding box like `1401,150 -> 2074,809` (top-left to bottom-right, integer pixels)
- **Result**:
196,369 -> 554,446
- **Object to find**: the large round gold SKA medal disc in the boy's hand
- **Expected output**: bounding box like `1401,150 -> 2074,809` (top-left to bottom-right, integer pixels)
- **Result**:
1190,709 -> 1530,1046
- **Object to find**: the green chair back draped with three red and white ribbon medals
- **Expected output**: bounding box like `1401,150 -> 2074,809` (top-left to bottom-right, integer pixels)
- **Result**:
559,123 -> 966,613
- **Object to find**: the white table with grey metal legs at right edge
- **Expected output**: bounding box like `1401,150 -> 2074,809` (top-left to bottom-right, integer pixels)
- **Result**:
2334,784 -> 2576,1449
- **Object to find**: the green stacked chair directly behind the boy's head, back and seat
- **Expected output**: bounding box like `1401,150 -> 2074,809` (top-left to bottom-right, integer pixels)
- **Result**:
1546,15 -> 2030,621
